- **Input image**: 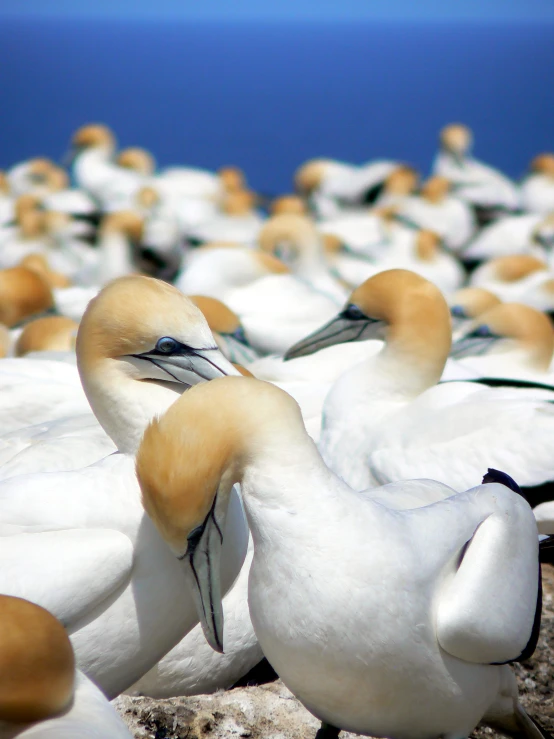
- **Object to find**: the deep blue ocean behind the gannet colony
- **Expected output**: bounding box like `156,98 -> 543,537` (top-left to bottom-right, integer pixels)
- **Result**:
0,19 -> 554,193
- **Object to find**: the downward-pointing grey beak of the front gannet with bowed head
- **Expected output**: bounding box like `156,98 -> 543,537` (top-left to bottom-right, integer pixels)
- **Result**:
179,491 -> 229,654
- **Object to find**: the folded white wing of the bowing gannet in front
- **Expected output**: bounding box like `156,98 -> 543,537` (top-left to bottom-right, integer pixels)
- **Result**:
430,483 -> 541,664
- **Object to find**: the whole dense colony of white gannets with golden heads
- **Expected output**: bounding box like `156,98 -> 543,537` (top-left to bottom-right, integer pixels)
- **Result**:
0,124 -> 554,739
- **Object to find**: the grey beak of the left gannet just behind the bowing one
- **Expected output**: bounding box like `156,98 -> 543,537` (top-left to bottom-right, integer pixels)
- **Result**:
132,346 -> 239,386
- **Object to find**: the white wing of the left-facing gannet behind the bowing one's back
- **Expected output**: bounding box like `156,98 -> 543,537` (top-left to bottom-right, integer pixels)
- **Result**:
369,383 -> 554,491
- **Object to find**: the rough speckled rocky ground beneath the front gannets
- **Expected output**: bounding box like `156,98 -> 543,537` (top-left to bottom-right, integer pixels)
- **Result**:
115,565 -> 554,739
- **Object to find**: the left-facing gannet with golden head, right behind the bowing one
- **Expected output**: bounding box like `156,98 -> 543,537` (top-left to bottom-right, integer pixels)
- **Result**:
286,270 -> 554,504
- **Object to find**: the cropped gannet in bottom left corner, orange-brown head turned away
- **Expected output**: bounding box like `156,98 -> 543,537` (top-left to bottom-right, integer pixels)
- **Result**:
0,595 -> 131,739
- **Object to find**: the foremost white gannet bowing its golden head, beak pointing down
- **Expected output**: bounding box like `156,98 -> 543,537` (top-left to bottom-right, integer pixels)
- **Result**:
137,378 -> 545,739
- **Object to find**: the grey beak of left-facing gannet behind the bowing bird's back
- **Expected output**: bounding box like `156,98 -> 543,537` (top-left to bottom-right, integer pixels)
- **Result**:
283,314 -> 386,361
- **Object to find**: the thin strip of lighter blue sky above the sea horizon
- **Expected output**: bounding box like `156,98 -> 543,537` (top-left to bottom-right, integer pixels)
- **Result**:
0,0 -> 554,22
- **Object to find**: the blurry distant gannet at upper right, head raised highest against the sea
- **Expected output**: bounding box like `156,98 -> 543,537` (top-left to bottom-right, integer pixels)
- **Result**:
433,123 -> 521,223
